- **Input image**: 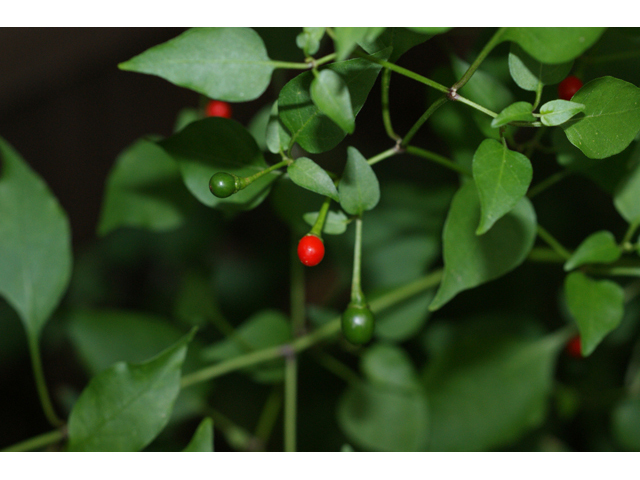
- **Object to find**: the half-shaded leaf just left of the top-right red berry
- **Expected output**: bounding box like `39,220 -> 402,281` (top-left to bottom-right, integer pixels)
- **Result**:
509,43 -> 573,92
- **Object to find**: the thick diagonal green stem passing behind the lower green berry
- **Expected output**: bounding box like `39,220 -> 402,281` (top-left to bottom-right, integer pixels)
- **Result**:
180,270 -> 442,388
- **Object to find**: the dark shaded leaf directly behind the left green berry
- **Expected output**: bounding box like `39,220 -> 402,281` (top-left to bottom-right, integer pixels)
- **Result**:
158,117 -> 278,210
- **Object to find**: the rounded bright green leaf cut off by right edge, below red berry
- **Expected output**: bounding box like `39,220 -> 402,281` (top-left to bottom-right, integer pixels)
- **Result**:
562,77 -> 640,158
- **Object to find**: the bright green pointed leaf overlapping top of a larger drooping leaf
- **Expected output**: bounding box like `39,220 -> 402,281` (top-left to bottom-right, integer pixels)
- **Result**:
472,139 -> 533,235
